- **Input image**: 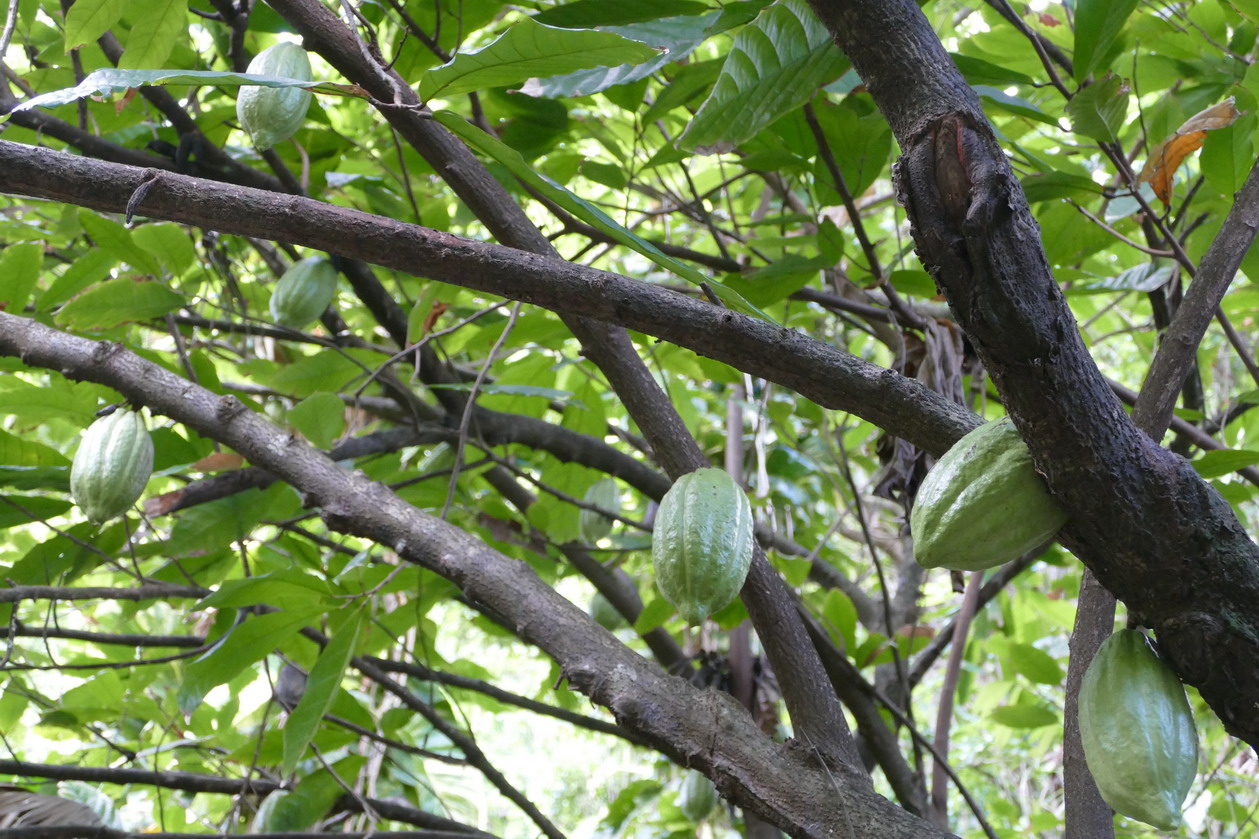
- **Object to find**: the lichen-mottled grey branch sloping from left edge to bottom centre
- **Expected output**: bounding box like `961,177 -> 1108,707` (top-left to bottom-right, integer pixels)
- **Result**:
0,312 -> 949,839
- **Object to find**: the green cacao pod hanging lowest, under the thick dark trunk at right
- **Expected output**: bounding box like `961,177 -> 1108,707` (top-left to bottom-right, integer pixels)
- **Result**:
1079,630 -> 1197,830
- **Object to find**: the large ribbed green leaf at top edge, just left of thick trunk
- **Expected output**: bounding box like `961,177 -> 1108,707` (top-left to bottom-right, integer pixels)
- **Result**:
679,0 -> 849,154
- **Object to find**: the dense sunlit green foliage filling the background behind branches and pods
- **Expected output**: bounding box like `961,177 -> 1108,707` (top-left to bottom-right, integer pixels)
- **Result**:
0,0 -> 1259,838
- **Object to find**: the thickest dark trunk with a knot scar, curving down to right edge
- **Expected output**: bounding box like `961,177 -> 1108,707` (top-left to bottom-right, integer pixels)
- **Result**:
813,0 -> 1259,746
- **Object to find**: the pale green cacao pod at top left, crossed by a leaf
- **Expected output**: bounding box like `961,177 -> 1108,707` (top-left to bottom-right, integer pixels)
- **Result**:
237,42 -> 315,151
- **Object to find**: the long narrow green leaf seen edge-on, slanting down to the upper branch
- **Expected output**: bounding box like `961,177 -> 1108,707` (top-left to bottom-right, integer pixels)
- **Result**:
433,111 -> 772,320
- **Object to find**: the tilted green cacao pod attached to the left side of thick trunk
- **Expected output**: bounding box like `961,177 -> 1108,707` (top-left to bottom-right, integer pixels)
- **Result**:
909,417 -> 1066,571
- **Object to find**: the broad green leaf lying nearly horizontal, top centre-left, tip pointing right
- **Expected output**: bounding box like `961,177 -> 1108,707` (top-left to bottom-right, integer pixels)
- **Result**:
419,18 -> 658,102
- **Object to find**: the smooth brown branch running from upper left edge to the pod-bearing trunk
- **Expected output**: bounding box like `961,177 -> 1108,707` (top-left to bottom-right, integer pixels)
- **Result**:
0,140 -> 978,455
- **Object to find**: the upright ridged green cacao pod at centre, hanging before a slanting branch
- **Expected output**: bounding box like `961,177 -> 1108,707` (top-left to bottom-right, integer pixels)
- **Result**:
651,469 -> 752,624
